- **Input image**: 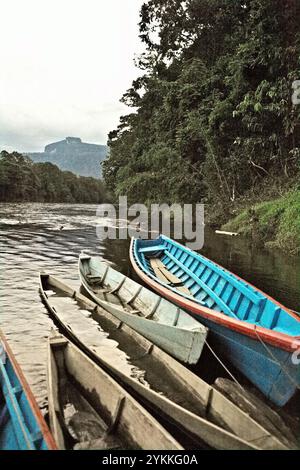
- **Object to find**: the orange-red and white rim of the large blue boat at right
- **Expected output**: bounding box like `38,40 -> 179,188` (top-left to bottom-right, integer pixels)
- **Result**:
129,237 -> 300,352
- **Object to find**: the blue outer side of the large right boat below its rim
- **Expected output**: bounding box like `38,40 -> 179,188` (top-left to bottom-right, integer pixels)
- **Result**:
197,318 -> 300,406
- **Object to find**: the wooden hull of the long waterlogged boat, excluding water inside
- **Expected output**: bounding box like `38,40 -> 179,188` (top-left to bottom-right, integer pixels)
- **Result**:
40,274 -> 286,449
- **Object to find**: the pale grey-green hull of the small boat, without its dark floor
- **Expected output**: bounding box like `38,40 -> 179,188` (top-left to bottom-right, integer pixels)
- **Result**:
79,256 -> 207,364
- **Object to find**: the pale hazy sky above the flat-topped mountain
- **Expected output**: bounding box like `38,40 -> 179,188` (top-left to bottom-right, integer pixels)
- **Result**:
0,0 -> 143,151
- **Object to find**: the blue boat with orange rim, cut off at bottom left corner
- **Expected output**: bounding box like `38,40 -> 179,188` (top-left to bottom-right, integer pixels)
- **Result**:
0,330 -> 57,450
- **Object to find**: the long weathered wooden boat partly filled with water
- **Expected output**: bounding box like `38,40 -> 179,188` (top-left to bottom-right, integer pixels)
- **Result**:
40,273 -> 286,449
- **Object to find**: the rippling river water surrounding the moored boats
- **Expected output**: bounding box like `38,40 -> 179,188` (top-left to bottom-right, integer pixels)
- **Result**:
0,204 -> 300,422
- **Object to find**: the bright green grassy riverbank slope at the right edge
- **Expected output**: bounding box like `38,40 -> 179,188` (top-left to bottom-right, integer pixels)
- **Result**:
222,189 -> 300,255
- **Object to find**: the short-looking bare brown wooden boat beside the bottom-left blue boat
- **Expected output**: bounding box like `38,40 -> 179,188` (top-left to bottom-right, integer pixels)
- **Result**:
48,332 -> 183,450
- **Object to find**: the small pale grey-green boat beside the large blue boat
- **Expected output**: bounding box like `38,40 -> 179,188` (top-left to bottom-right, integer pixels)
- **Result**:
79,256 -> 207,364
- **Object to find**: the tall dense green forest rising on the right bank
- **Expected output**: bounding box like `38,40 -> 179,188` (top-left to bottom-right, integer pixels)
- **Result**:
103,0 -> 300,220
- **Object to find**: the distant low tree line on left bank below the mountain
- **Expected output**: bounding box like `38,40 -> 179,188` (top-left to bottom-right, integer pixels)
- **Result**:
0,151 -> 107,203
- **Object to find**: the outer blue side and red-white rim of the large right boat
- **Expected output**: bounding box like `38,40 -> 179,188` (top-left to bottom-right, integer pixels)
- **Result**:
130,239 -> 300,406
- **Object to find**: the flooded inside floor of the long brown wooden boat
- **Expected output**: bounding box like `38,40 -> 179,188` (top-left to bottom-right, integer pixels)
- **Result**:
46,287 -> 210,426
